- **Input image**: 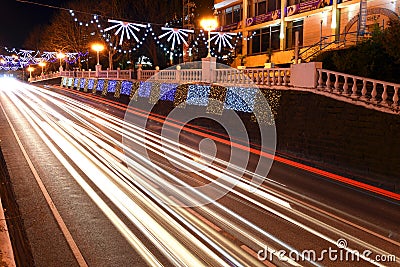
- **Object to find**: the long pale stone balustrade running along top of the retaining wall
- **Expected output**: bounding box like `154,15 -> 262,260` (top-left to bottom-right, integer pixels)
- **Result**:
31,62 -> 400,114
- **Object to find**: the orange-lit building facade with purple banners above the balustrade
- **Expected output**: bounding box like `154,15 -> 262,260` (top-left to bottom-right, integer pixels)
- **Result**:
214,0 -> 400,67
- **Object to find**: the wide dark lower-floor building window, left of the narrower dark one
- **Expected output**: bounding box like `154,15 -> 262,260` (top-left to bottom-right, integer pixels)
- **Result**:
248,26 -> 280,54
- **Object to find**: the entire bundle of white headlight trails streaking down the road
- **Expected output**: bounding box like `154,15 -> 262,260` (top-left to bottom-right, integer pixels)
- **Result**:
2,81 -> 396,266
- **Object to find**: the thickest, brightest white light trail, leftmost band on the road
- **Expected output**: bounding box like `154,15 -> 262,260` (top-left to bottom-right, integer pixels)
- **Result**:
5,87 -> 231,266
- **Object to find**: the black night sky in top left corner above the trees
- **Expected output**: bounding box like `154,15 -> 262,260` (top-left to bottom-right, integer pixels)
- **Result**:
0,0 -> 67,49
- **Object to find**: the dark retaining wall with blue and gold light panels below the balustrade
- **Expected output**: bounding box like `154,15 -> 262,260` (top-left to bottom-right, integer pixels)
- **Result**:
61,78 -> 400,191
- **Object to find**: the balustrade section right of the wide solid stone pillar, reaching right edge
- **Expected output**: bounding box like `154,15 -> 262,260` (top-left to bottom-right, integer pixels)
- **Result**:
317,69 -> 400,110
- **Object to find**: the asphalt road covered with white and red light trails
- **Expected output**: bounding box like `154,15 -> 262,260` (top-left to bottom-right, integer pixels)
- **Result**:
0,78 -> 400,266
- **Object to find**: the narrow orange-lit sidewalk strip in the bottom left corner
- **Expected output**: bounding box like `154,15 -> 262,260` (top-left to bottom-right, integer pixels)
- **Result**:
0,198 -> 16,267
